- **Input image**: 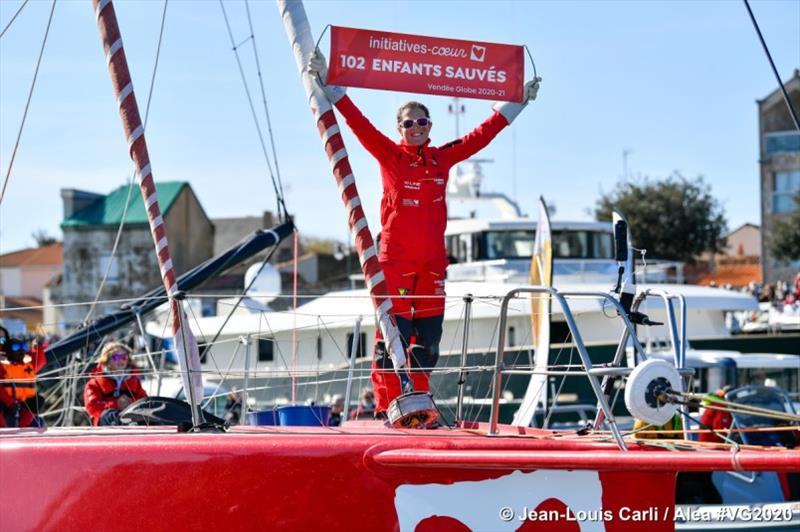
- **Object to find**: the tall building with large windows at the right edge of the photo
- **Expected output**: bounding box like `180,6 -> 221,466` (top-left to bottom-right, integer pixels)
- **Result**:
757,69 -> 800,283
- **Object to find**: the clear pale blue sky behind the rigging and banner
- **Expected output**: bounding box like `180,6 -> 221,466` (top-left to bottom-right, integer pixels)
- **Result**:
0,0 -> 800,252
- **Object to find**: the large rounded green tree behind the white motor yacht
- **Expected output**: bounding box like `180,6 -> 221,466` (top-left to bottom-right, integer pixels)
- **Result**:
594,172 -> 727,262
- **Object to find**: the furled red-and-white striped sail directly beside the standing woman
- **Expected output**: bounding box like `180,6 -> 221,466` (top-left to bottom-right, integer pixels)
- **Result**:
277,0 -> 405,378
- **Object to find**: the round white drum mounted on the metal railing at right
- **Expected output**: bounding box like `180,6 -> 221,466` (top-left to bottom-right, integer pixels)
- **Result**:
625,359 -> 683,425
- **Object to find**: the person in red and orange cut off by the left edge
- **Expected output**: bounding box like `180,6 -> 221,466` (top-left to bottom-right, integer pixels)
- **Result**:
0,327 -> 47,427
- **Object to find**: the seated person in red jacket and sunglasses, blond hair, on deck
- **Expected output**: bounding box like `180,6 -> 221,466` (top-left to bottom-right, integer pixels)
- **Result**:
83,342 -> 147,426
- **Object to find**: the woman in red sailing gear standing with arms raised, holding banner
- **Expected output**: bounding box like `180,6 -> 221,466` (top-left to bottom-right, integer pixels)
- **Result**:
308,51 -> 541,415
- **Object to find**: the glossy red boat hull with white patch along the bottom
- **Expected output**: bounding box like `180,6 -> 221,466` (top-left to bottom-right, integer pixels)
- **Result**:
0,423 -> 800,531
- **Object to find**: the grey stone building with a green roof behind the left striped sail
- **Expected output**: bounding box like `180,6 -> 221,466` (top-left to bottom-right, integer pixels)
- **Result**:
47,181 -> 214,331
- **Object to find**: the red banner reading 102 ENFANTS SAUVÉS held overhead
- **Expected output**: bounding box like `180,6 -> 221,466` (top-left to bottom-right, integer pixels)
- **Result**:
328,26 -> 525,102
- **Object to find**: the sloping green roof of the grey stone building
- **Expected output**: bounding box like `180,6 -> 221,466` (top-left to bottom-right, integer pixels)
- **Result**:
61,181 -> 189,228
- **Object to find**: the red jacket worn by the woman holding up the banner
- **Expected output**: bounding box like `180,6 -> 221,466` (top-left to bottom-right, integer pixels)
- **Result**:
336,96 -> 508,263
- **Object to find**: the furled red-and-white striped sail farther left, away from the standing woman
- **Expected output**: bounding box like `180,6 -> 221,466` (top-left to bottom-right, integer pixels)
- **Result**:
92,0 -> 203,398
